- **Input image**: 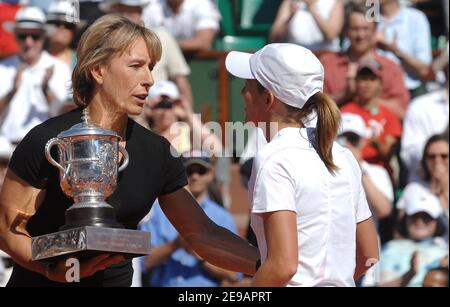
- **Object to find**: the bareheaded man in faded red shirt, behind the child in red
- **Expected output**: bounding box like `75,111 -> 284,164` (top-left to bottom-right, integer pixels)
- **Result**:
320,5 -> 410,119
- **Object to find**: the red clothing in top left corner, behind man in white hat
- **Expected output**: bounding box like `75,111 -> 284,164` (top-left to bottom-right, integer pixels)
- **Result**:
0,0 -> 21,59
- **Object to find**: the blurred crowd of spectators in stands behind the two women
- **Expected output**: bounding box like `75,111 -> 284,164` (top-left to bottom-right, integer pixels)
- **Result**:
0,0 -> 449,287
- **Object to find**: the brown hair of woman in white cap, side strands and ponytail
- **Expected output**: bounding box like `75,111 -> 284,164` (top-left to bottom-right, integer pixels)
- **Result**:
283,92 -> 341,173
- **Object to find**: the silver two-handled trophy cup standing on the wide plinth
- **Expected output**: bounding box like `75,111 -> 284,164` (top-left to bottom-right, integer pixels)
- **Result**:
45,126 -> 129,229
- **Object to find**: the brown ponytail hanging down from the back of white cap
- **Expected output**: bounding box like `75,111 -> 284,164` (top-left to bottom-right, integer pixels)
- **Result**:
306,92 -> 341,173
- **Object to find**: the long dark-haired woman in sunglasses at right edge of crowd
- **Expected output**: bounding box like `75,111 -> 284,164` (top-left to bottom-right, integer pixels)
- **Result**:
397,134 -> 449,243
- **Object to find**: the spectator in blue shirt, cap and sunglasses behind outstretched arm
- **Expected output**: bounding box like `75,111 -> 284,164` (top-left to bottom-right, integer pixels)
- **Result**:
141,151 -> 241,287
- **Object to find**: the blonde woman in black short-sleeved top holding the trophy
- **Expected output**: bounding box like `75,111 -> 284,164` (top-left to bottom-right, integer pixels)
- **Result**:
0,16 -> 259,286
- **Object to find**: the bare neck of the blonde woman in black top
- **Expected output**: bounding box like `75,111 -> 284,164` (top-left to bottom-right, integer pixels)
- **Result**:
87,96 -> 128,140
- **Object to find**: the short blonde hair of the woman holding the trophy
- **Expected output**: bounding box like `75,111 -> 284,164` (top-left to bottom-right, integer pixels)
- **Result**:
72,15 -> 161,107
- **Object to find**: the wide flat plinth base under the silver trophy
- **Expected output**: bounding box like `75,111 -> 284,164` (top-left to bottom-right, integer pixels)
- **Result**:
31,226 -> 150,262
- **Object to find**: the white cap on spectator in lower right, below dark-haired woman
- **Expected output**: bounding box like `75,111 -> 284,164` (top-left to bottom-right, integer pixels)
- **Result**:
405,191 -> 443,219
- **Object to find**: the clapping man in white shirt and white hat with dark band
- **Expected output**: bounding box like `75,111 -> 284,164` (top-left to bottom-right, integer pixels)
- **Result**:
0,7 -> 71,143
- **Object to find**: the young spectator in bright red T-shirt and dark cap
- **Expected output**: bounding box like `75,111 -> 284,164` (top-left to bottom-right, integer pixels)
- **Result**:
341,60 -> 402,177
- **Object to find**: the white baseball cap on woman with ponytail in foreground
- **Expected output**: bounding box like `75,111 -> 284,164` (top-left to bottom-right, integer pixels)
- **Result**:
225,44 -> 324,109
